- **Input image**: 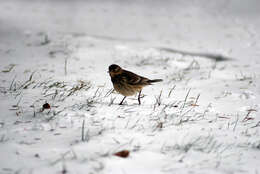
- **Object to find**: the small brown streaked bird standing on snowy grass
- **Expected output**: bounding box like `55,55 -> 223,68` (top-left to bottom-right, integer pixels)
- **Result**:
108,64 -> 162,105
